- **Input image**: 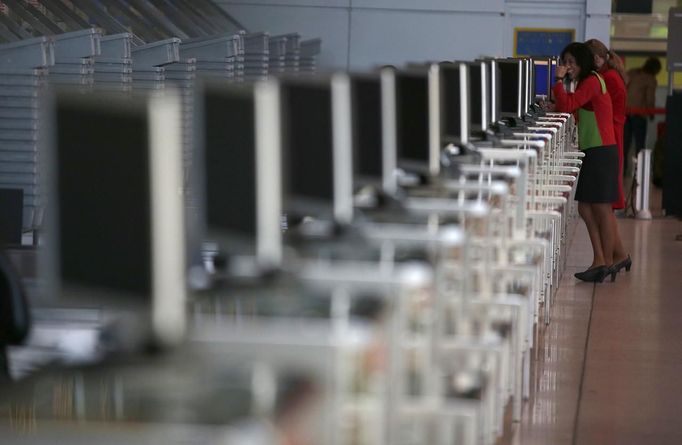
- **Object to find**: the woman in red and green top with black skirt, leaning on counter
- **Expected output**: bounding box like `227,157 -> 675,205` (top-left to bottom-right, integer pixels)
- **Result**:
552,42 -> 627,282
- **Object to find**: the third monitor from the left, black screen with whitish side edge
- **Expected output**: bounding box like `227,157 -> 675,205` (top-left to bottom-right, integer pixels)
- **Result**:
280,74 -> 353,223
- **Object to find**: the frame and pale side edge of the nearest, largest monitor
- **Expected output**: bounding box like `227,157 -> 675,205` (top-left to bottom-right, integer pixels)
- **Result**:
38,88 -> 187,346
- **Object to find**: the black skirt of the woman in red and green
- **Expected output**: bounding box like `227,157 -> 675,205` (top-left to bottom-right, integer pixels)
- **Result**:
575,145 -> 618,203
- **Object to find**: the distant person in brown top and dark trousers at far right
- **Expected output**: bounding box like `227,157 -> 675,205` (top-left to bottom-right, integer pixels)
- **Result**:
623,57 -> 661,177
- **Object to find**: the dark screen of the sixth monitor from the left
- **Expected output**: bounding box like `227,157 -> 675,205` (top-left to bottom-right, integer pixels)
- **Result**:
440,63 -> 466,142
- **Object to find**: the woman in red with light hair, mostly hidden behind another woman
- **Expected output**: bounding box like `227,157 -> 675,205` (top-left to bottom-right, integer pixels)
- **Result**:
585,39 -> 632,271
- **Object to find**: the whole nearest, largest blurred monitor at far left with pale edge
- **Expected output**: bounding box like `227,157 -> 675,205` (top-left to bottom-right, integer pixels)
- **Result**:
41,91 -> 186,342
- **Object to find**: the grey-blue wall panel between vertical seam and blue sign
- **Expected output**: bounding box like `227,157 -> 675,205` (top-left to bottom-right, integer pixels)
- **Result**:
350,9 -> 504,69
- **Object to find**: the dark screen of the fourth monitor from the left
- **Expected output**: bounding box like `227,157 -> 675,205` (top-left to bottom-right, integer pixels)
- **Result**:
351,76 -> 383,185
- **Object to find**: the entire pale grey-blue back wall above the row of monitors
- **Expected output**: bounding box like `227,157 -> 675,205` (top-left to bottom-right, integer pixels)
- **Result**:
216,0 -> 610,69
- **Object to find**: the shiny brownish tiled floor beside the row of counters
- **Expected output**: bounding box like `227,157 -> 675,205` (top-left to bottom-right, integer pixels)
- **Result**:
504,189 -> 682,445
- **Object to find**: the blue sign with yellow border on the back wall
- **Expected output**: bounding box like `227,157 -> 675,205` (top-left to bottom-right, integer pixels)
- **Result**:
514,28 -> 575,57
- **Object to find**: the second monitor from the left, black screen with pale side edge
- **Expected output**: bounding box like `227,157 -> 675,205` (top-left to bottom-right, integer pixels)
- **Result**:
194,82 -> 282,268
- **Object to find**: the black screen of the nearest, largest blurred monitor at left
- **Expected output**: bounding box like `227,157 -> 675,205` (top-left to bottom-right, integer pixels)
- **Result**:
51,100 -> 152,298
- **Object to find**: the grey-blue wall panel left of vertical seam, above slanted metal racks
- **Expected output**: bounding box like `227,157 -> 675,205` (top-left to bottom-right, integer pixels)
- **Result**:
222,4 -> 349,69
